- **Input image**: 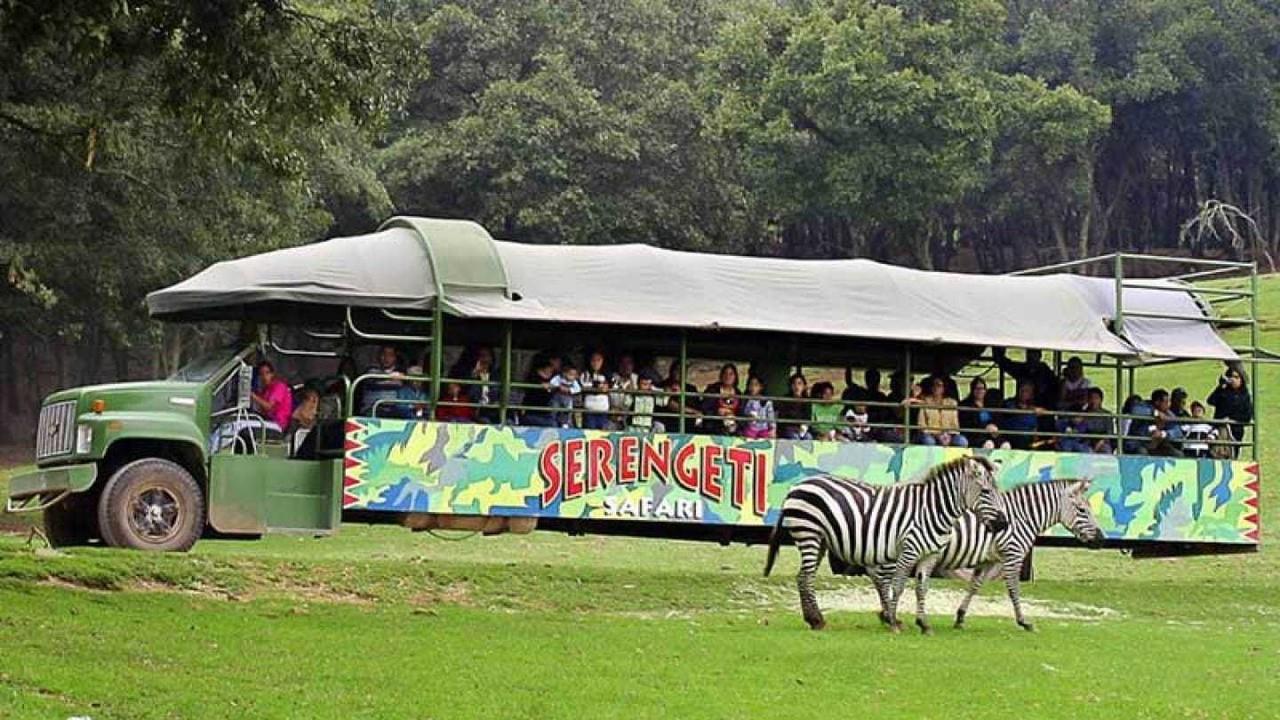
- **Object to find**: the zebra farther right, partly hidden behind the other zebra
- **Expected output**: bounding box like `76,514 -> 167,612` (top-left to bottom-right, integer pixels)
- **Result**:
869,479 -> 1105,633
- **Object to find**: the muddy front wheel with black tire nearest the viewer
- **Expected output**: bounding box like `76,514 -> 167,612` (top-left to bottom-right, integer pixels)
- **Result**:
97,457 -> 205,552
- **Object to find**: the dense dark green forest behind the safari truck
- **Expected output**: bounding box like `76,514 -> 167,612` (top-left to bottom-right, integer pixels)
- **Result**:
0,0 -> 1280,439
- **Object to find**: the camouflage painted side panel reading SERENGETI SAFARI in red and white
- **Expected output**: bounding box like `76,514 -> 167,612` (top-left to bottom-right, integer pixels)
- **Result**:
343,419 -> 1258,543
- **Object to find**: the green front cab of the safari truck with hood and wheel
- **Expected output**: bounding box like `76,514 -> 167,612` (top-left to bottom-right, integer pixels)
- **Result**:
6,346 -> 342,551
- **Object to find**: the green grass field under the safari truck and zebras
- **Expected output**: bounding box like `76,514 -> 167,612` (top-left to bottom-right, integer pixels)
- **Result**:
0,279 -> 1280,719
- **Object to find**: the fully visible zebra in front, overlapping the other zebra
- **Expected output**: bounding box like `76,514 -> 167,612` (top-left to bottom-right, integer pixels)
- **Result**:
764,456 -> 1007,632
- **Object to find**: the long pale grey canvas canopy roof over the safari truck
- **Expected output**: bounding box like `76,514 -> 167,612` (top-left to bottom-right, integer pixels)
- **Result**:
147,212 -> 1236,360
